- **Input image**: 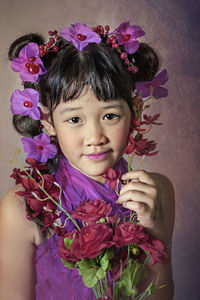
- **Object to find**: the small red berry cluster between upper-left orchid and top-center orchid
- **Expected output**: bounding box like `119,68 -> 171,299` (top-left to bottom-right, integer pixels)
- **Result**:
39,30 -> 60,57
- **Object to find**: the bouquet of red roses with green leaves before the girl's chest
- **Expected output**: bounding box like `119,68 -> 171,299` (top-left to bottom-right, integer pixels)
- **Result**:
58,200 -> 168,300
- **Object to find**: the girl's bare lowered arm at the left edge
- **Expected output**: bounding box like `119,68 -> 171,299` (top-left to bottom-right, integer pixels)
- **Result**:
0,187 -> 39,300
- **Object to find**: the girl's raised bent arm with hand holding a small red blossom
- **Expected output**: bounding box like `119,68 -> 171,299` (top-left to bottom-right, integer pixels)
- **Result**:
118,171 -> 175,300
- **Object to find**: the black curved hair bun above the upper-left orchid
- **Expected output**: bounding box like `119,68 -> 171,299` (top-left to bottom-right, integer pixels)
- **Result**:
8,33 -> 44,60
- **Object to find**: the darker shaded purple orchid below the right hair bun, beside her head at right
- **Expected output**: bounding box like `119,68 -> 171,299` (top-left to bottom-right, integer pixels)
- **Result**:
136,69 -> 169,98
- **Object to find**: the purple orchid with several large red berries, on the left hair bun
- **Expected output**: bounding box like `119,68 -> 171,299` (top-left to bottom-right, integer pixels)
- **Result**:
11,43 -> 47,82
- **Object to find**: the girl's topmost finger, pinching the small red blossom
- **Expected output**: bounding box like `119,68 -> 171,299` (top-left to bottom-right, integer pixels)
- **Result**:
122,170 -> 156,186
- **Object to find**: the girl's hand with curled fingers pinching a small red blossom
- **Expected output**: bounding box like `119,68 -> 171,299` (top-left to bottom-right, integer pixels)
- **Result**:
117,170 -> 162,229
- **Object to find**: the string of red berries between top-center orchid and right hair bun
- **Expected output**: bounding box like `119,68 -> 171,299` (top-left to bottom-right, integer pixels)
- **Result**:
92,25 -> 138,74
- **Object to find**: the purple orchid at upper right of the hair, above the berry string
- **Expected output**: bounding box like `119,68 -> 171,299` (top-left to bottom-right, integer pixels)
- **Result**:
114,21 -> 145,54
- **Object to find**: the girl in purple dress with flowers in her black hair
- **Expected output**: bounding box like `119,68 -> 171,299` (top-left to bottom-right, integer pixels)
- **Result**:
0,22 -> 174,300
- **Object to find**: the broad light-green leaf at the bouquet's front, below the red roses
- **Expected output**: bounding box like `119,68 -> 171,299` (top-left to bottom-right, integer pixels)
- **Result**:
79,258 -> 106,288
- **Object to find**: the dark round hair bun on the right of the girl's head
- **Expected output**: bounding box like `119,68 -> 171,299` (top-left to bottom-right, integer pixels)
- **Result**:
133,43 -> 160,81
